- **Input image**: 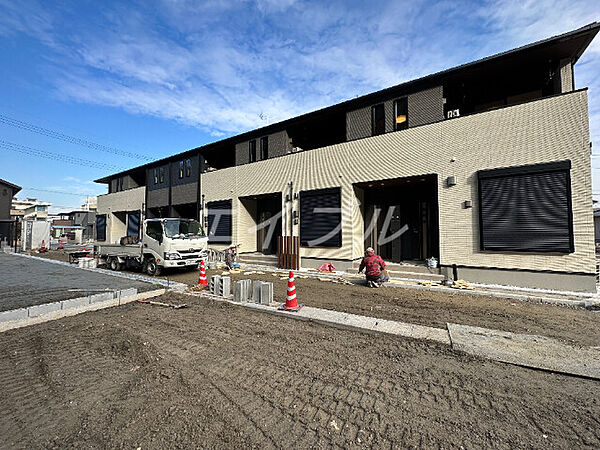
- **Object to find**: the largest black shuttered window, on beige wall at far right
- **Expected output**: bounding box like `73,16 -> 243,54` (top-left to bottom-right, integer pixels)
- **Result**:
478,161 -> 574,253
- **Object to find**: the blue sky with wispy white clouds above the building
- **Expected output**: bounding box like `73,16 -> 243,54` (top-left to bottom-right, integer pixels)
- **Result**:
0,0 -> 600,212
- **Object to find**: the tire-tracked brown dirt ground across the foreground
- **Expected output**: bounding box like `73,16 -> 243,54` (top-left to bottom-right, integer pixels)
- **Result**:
0,294 -> 600,449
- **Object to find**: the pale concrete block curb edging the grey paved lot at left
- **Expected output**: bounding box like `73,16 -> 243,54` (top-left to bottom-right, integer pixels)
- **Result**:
0,288 -> 167,333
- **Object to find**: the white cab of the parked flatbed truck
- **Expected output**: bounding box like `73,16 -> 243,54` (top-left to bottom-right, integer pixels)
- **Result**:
142,218 -> 208,275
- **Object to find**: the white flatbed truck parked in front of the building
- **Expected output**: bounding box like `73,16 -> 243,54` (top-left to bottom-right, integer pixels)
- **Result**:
94,218 -> 208,276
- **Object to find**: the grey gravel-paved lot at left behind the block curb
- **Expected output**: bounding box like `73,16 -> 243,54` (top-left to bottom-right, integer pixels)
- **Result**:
0,253 -> 151,311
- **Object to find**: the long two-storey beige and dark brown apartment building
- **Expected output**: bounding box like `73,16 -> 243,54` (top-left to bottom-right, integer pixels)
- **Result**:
96,23 -> 600,291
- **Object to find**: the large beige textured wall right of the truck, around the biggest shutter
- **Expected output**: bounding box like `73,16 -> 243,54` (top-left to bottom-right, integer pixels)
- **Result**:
202,91 -> 595,273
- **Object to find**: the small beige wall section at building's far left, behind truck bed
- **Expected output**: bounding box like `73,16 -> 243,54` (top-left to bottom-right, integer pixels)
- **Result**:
97,186 -> 146,242
